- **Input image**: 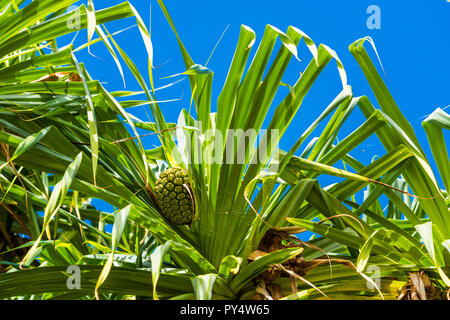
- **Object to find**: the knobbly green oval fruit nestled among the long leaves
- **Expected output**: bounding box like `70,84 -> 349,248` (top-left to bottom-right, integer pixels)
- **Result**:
155,168 -> 194,225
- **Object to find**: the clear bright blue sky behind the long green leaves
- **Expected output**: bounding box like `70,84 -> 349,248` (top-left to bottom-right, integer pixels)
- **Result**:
67,0 -> 450,218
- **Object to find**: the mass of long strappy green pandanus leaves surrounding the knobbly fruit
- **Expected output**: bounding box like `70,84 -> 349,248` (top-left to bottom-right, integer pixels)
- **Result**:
0,0 -> 450,299
